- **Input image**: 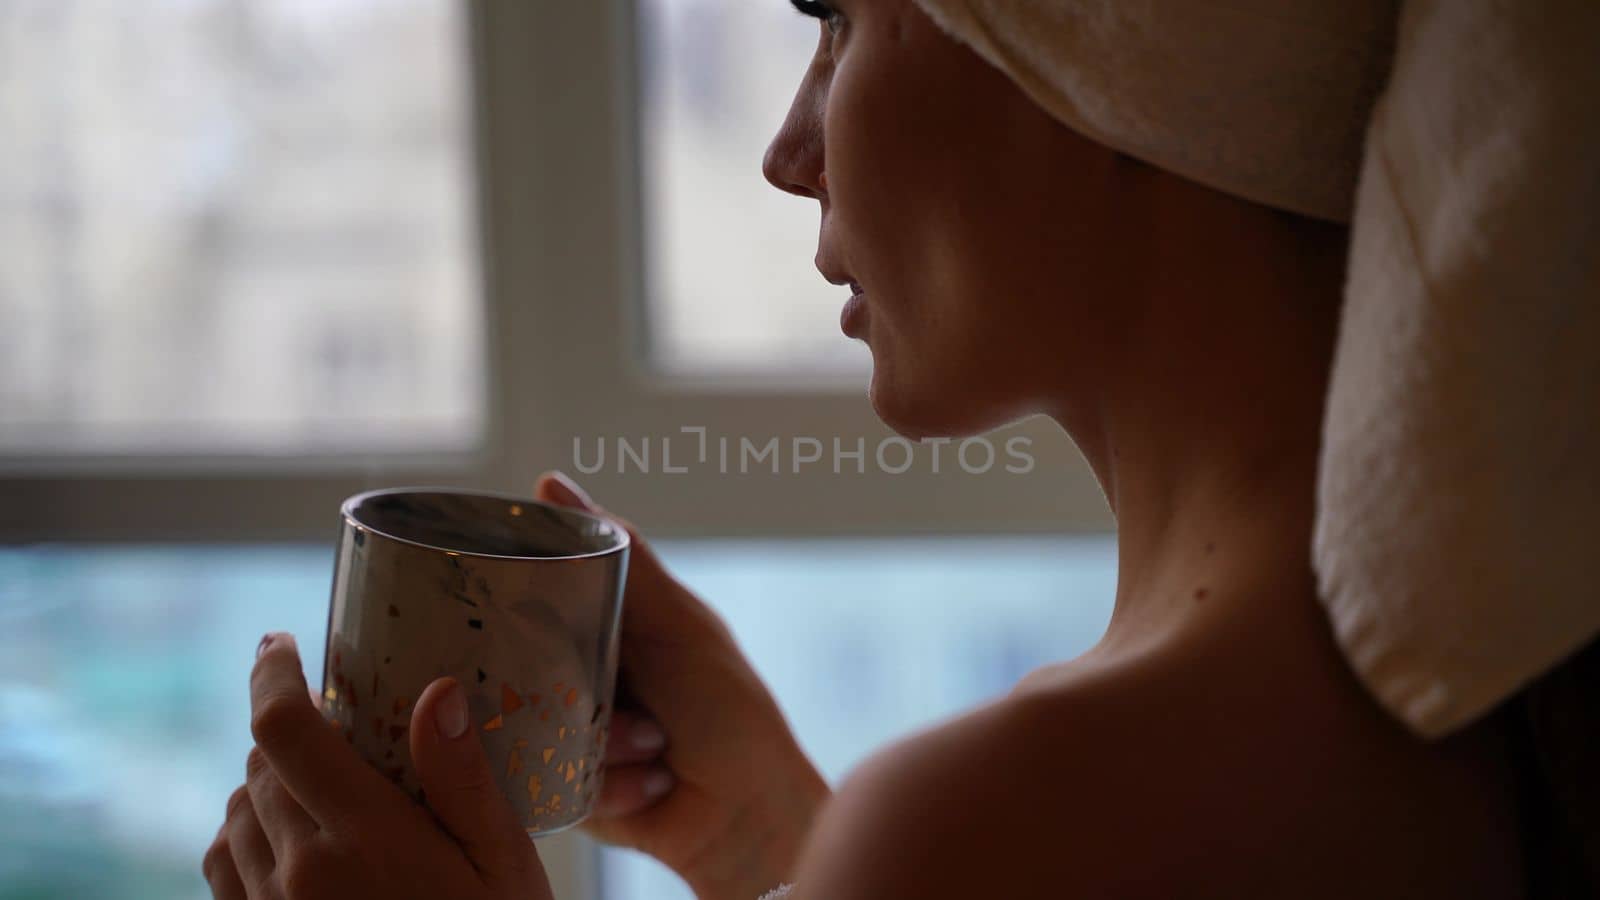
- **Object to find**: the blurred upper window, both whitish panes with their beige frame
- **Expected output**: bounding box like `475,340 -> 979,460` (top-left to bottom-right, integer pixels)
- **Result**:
0,0 -> 1106,540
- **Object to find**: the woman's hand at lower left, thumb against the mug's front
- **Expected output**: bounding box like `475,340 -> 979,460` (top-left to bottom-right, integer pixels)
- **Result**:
202,634 -> 550,900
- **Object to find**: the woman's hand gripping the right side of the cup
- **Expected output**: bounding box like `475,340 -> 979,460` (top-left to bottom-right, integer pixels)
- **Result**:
538,472 -> 829,900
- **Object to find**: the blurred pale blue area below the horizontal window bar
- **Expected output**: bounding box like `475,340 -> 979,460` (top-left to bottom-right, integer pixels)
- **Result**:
0,538 -> 1115,900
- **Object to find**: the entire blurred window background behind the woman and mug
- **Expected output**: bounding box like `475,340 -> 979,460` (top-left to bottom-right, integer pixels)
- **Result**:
0,0 -> 1115,900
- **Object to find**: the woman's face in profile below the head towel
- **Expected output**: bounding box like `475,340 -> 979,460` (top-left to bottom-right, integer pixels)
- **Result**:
763,0 -> 1138,437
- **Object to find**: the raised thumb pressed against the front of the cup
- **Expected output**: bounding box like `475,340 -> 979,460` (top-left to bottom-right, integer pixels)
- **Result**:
411,677 -> 538,878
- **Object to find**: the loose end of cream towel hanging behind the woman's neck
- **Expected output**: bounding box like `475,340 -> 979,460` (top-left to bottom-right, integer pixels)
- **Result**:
1314,0 -> 1600,737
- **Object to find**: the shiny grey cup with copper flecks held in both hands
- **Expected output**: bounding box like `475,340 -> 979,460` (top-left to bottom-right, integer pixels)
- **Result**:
322,488 -> 629,836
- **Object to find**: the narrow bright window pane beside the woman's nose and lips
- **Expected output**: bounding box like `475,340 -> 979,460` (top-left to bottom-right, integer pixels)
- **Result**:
638,0 -> 867,373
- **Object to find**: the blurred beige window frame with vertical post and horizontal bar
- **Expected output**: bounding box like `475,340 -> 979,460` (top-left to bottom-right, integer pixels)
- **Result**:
0,0 -> 1109,541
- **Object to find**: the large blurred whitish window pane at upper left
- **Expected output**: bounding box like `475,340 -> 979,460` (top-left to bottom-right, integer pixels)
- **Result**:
0,0 -> 483,455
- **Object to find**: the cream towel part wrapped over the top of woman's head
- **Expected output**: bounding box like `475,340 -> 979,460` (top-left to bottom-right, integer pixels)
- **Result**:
918,0 -> 1398,221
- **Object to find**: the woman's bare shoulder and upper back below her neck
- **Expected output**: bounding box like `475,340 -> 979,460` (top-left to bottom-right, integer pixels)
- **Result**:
795,621 -> 1517,900
